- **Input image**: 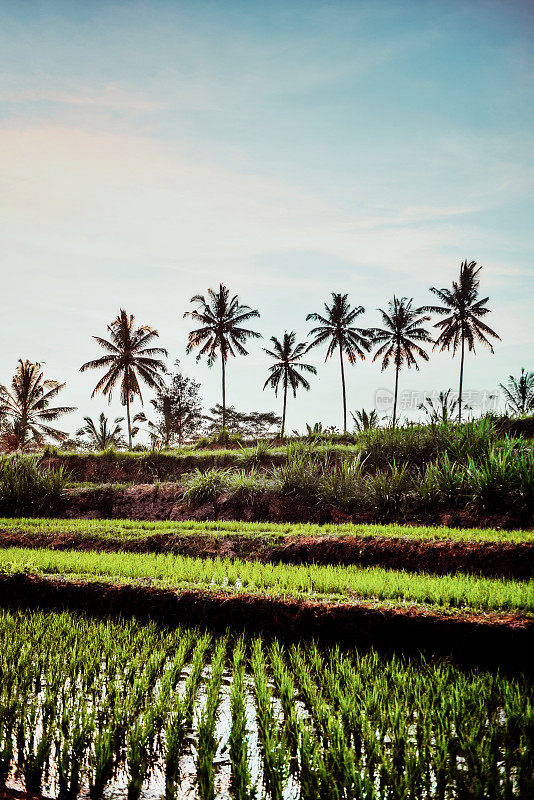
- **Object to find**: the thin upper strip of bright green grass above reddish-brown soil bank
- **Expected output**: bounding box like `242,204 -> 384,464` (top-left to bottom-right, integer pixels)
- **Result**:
0,517 -> 534,542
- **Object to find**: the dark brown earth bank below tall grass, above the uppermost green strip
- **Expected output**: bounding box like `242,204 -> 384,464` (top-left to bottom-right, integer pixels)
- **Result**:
60,484 -> 524,529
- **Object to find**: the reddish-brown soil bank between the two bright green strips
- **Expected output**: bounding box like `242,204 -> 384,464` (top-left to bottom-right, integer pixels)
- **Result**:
0,530 -> 534,579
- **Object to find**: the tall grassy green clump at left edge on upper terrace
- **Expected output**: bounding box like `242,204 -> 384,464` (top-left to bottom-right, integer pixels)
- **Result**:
0,453 -> 70,517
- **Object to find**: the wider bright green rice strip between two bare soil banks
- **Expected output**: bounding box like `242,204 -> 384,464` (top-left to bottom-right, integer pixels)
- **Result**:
0,548 -> 534,613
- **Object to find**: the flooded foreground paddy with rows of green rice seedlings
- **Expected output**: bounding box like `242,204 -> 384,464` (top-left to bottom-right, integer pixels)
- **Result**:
0,611 -> 534,800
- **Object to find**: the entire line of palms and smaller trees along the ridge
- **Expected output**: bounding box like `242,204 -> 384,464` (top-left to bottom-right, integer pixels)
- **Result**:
0,261 -> 534,448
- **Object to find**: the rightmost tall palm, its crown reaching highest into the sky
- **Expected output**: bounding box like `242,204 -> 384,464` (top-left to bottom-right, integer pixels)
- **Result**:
424,261 -> 501,422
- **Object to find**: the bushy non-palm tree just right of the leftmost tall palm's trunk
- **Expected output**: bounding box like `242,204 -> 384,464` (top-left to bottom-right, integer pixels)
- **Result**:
144,361 -> 202,447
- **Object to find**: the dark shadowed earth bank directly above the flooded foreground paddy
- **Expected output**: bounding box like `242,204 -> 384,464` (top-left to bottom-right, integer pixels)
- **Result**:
0,574 -> 534,669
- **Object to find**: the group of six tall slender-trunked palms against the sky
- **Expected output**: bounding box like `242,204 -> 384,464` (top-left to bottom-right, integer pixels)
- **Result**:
76,261 -> 500,447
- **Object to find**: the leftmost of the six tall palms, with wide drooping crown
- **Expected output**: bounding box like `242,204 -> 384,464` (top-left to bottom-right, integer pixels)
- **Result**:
80,308 -> 167,449
